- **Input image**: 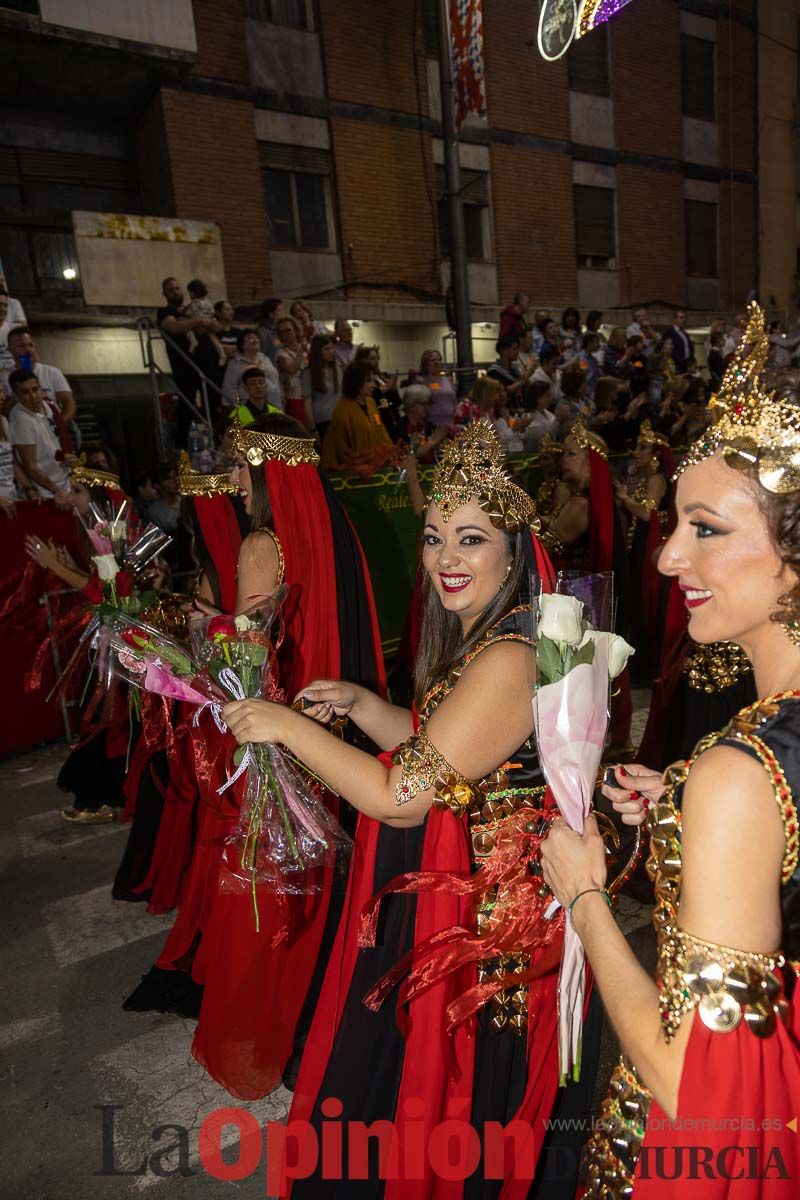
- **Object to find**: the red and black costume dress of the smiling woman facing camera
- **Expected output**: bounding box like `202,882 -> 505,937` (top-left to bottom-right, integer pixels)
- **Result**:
289,595 -> 599,1200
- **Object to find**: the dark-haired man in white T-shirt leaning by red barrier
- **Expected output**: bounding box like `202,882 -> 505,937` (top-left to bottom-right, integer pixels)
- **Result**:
8,370 -> 70,504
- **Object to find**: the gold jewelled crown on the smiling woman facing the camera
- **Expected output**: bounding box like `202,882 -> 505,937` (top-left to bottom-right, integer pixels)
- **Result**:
428,420 -> 540,533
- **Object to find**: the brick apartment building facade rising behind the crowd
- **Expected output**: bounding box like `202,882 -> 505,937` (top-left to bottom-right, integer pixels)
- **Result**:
0,0 -> 759,323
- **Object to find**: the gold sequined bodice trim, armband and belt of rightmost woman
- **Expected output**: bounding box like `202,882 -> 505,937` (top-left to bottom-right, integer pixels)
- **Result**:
583,692 -> 800,1200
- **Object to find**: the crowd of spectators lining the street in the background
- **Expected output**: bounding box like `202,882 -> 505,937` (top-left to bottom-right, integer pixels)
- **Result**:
0,268 -> 800,549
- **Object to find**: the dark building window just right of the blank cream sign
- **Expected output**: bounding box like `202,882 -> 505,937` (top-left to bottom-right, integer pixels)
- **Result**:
259,142 -> 335,250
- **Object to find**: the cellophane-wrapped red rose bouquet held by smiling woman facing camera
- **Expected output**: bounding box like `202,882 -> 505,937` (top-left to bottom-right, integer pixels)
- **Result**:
192,602 -> 350,930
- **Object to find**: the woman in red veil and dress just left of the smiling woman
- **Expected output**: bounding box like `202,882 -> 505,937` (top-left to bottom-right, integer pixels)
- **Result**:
126,415 -> 385,1099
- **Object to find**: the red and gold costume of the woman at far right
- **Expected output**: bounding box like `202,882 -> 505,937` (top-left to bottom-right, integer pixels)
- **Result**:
584,692 -> 800,1200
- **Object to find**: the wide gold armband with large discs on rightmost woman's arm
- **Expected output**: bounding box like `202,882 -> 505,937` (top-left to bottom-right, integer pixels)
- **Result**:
658,926 -> 787,1042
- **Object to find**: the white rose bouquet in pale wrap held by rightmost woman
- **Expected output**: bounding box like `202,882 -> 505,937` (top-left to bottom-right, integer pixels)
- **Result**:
534,575 -> 632,1082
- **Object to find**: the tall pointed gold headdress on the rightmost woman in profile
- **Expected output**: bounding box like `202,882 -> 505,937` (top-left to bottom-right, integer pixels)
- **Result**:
675,302 -> 800,494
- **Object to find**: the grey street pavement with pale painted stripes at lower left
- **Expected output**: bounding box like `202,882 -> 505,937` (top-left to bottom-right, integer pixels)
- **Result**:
0,714 -> 649,1200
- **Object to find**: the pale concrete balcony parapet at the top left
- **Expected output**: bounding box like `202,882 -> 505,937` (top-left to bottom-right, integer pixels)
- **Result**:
38,0 -> 197,54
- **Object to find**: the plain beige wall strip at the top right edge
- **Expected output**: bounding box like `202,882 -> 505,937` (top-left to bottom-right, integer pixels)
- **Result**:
758,0 -> 800,307
